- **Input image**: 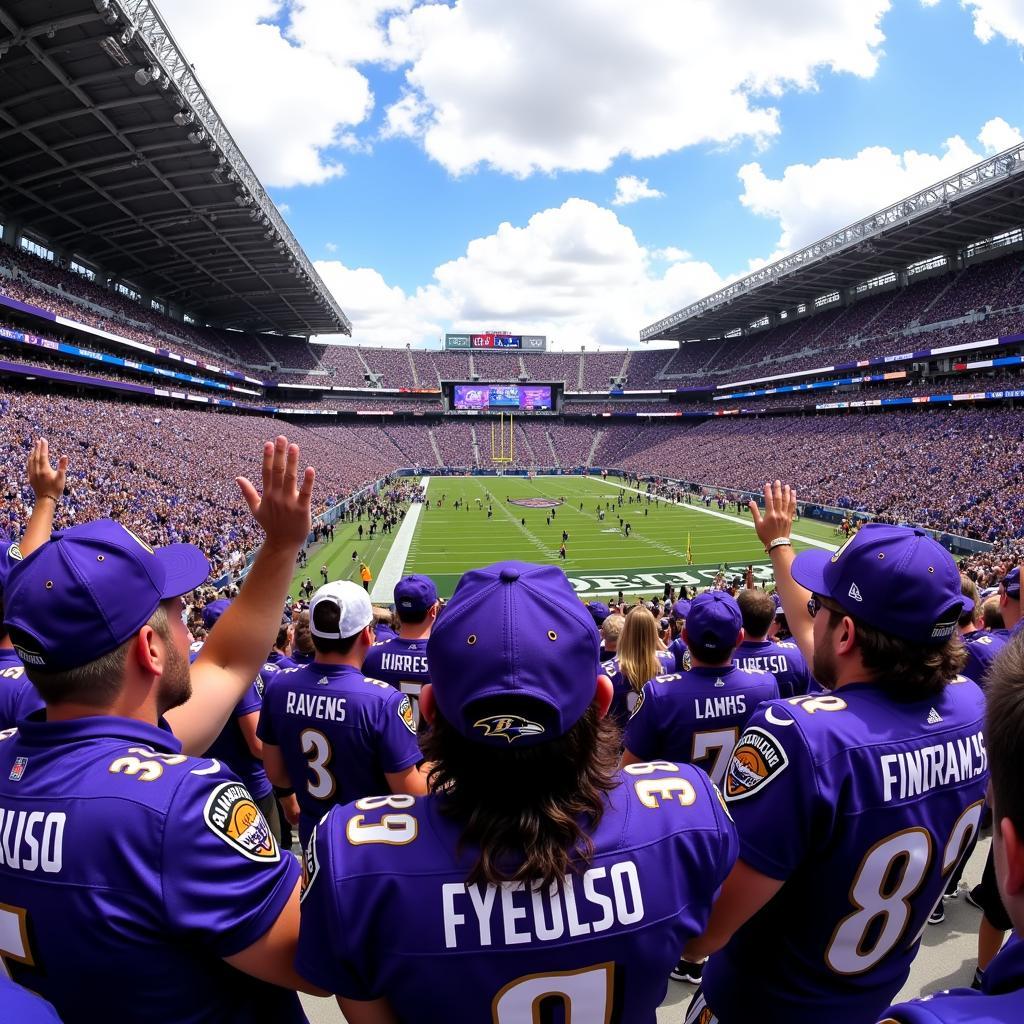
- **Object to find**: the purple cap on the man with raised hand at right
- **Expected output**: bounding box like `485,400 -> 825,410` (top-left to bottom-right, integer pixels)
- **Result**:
793,522 -> 974,644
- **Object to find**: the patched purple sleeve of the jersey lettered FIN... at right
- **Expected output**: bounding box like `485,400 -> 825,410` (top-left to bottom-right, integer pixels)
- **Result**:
724,701 -> 828,881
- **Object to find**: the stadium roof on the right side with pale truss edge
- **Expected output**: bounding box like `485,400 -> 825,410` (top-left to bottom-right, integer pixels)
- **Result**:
640,145 -> 1024,341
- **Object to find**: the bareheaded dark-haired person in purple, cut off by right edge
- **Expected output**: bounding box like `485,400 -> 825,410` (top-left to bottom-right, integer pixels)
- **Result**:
883,636 -> 1024,1024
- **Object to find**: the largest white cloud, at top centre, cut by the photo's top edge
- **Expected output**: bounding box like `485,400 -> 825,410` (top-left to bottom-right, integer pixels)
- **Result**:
387,0 -> 890,176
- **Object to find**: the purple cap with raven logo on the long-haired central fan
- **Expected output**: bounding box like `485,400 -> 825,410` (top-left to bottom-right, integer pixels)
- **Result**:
427,561 -> 601,748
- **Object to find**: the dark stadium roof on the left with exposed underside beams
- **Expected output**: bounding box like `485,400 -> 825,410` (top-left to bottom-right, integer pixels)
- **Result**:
0,0 -> 351,335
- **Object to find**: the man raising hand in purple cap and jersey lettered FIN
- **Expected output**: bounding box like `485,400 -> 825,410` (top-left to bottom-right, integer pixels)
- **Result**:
685,481 -> 988,1024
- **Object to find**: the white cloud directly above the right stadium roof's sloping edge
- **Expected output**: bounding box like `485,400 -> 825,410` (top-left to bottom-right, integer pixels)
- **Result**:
739,118 -> 1020,260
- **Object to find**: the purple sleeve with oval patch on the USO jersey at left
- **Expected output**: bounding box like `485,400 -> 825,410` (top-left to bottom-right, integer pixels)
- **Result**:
162,761 -> 299,957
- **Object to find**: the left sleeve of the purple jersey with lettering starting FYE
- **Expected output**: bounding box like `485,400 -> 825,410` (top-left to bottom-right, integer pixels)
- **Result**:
295,807 -> 381,1000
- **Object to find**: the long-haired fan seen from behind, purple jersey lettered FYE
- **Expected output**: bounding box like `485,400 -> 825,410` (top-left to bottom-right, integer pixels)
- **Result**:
296,562 -> 735,1024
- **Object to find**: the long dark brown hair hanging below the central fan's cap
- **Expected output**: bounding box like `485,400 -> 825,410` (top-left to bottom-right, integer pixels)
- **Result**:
423,698 -> 622,885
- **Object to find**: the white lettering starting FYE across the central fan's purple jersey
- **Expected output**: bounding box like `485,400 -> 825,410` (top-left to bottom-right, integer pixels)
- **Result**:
441,860 -> 644,949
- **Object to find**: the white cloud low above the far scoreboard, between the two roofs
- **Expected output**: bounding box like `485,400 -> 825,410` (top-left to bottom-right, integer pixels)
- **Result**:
316,199 -> 722,350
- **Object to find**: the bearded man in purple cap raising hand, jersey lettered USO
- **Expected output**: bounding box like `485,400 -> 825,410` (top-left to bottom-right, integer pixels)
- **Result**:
0,437 -> 323,1024
